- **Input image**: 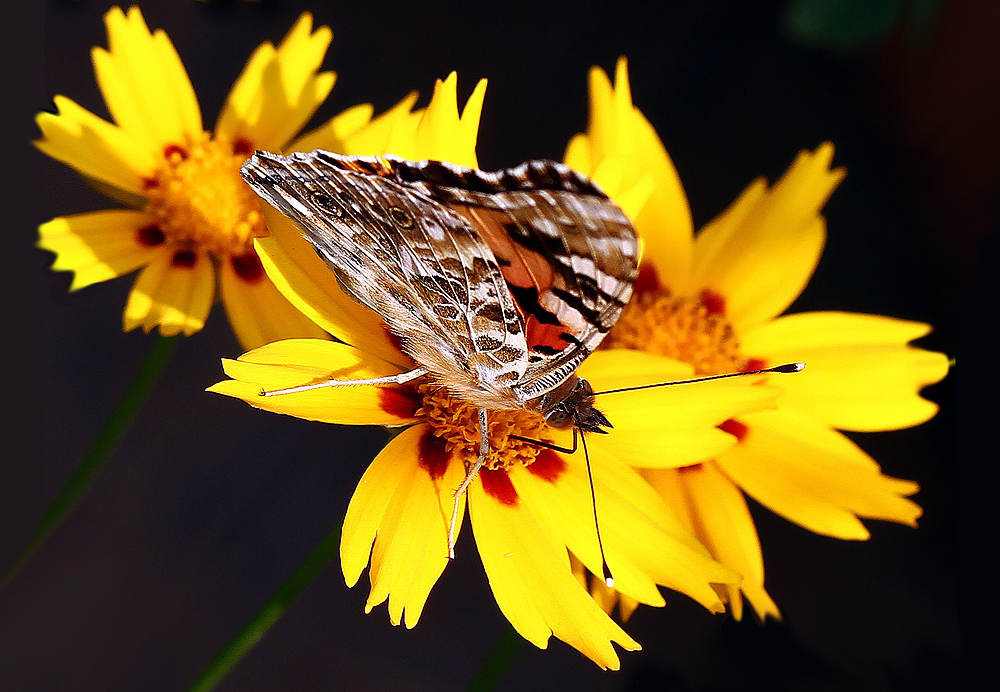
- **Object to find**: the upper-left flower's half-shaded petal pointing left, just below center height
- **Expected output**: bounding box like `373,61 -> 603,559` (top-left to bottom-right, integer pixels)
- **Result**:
38,210 -> 163,291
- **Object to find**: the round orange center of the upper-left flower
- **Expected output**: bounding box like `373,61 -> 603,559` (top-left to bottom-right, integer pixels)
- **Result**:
145,132 -> 265,258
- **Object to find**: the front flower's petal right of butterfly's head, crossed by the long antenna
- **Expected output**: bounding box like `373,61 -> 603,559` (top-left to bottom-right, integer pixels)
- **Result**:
579,349 -> 780,468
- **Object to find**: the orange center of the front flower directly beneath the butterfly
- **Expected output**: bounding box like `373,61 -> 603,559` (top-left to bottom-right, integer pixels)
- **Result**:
416,383 -> 548,471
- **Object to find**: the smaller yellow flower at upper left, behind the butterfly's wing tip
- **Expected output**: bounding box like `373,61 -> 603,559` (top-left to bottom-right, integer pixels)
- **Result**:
35,7 -> 382,348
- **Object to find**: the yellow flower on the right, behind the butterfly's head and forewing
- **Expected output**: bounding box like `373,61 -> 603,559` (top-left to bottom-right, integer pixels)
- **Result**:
566,59 -> 948,618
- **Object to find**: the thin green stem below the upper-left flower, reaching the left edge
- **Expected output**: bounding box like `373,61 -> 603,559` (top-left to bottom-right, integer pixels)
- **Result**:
0,336 -> 179,589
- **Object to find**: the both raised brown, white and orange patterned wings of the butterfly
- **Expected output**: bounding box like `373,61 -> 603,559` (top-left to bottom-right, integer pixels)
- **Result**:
243,151 -> 638,413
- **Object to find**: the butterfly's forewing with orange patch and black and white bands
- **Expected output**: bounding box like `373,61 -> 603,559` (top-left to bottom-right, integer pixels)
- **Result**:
386,160 -> 639,400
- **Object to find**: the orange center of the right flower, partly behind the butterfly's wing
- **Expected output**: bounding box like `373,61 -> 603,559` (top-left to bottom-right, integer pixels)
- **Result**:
601,286 -> 757,375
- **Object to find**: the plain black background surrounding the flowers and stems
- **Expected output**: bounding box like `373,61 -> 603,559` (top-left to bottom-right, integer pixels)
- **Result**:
7,0 -> 976,692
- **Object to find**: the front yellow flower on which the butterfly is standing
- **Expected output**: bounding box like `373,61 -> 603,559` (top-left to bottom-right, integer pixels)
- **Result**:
210,74 -> 774,668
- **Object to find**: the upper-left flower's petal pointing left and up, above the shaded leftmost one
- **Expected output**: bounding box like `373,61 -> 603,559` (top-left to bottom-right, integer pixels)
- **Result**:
34,96 -> 156,194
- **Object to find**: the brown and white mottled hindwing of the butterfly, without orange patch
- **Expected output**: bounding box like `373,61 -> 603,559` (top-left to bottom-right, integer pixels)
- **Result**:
242,151 -> 527,408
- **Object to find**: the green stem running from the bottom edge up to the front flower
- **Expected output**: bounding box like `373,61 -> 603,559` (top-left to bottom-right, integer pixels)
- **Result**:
188,522 -> 343,692
